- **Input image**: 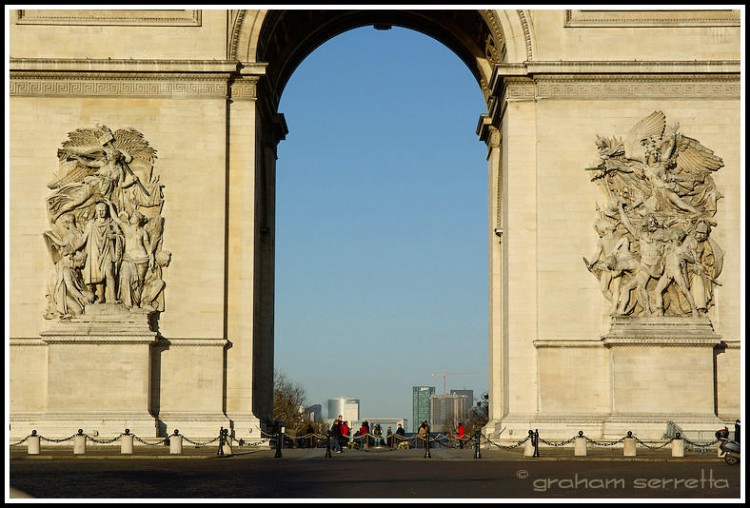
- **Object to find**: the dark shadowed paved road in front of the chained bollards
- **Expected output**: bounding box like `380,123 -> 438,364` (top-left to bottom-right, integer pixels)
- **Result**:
6,449 -> 741,502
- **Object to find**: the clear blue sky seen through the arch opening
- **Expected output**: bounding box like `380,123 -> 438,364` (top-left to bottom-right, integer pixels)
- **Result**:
274,27 -> 488,421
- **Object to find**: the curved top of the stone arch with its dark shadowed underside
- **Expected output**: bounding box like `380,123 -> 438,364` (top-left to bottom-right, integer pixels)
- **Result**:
227,9 -> 533,106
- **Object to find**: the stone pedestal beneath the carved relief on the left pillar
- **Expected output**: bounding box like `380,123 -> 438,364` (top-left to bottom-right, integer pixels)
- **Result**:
31,304 -> 157,438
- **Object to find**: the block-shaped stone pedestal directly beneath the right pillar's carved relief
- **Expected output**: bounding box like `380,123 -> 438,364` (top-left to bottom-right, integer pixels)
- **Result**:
602,316 -> 721,439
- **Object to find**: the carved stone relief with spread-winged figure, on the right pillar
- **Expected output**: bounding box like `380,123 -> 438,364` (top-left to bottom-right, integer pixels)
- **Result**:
583,111 -> 724,317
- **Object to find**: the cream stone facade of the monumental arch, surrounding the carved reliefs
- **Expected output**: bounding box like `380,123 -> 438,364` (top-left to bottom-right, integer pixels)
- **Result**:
7,9 -> 743,440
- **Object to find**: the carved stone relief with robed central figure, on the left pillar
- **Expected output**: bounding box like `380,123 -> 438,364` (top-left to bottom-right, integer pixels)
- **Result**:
43,125 -> 171,320
